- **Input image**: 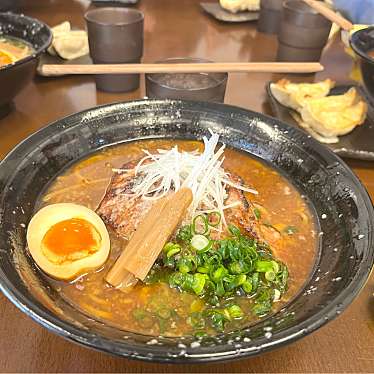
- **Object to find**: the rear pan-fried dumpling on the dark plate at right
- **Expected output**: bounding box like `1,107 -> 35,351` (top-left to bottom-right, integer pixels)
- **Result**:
270,79 -> 335,110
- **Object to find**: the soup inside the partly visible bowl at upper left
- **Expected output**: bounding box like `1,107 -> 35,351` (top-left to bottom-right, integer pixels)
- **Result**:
0,35 -> 34,67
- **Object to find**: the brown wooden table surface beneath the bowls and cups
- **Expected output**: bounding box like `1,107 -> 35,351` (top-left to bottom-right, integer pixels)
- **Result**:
0,0 -> 374,372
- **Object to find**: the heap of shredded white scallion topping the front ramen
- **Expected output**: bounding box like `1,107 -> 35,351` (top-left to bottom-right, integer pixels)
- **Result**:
116,132 -> 258,231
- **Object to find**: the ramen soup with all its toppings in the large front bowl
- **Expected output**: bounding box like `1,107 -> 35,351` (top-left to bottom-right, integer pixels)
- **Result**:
28,134 -> 317,336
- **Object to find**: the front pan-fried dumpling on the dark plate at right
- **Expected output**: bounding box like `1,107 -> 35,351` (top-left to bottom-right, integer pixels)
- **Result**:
300,88 -> 367,137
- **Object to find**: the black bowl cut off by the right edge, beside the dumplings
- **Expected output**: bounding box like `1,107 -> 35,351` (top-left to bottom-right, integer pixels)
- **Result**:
350,26 -> 374,103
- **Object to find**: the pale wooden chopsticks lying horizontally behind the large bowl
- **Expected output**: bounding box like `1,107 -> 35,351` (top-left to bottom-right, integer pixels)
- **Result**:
38,62 -> 323,76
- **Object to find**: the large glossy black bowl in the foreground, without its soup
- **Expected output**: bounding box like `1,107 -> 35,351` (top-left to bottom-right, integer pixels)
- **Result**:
0,100 -> 374,363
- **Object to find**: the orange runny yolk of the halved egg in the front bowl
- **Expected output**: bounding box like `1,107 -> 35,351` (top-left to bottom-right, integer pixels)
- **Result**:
42,218 -> 101,262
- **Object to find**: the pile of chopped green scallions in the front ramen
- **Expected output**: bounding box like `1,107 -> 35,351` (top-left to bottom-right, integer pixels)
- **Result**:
152,221 -> 288,331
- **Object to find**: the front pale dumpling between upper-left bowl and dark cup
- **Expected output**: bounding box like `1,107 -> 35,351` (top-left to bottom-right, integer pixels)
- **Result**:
53,30 -> 89,60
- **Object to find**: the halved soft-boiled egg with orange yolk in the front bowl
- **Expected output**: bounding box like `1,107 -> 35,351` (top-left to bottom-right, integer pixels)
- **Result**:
27,203 -> 110,280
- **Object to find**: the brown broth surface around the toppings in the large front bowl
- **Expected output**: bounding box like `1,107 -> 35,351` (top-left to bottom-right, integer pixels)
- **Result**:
41,140 -> 316,336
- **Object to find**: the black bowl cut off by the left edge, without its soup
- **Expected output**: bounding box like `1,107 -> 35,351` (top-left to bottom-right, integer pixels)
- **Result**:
0,13 -> 52,118
